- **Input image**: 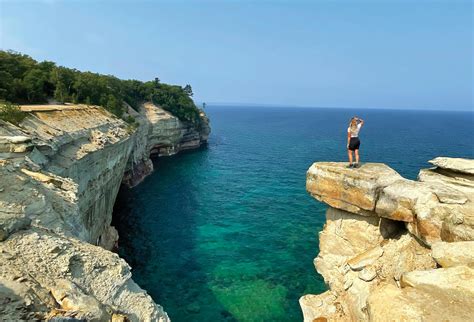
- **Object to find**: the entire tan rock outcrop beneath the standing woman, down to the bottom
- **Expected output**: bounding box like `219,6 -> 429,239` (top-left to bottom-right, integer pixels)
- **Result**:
300,158 -> 474,321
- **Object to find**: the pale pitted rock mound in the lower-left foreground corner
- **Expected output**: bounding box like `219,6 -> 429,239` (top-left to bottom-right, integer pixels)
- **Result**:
0,227 -> 168,321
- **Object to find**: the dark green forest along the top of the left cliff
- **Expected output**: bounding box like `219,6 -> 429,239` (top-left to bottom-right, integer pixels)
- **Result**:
0,50 -> 200,125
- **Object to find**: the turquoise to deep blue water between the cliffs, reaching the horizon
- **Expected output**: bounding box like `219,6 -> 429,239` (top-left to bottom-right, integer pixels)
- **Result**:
114,107 -> 474,321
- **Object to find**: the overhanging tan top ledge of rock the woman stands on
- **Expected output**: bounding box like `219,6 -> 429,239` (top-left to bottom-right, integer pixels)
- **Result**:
306,158 -> 474,245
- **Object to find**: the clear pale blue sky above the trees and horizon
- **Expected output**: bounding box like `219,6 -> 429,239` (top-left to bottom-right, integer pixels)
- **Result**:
0,0 -> 474,110
